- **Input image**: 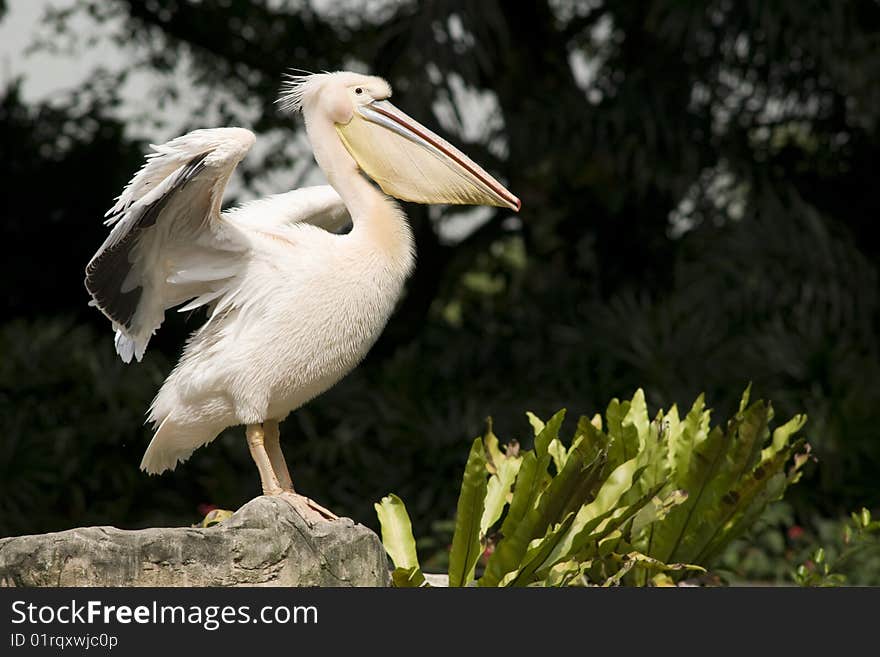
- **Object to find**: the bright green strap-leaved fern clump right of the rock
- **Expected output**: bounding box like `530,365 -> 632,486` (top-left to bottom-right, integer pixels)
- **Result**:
375,390 -> 809,586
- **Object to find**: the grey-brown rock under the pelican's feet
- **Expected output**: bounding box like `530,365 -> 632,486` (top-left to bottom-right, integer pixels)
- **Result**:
0,496 -> 390,586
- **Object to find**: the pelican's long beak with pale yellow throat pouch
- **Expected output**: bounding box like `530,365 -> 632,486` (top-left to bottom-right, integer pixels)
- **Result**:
336,100 -> 520,211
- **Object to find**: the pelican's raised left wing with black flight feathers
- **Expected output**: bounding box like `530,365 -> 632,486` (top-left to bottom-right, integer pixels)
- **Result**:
85,128 -> 254,362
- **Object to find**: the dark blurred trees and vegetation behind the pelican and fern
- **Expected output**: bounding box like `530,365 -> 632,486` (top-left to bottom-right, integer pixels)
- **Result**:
0,0 -> 880,580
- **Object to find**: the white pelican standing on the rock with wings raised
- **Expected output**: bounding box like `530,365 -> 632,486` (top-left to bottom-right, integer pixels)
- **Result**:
85,72 -> 520,519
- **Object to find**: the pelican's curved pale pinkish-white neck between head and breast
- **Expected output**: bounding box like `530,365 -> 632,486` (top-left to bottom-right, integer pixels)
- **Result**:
306,116 -> 413,266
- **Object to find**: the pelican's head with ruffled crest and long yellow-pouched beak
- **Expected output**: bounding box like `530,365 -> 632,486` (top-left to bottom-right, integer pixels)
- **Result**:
279,71 -> 520,210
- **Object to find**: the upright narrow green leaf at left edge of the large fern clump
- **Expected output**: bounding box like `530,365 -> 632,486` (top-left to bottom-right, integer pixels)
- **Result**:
449,438 -> 487,587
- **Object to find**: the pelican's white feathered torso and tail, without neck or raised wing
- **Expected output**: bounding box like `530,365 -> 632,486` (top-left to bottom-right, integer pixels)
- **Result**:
144,195 -> 414,472
